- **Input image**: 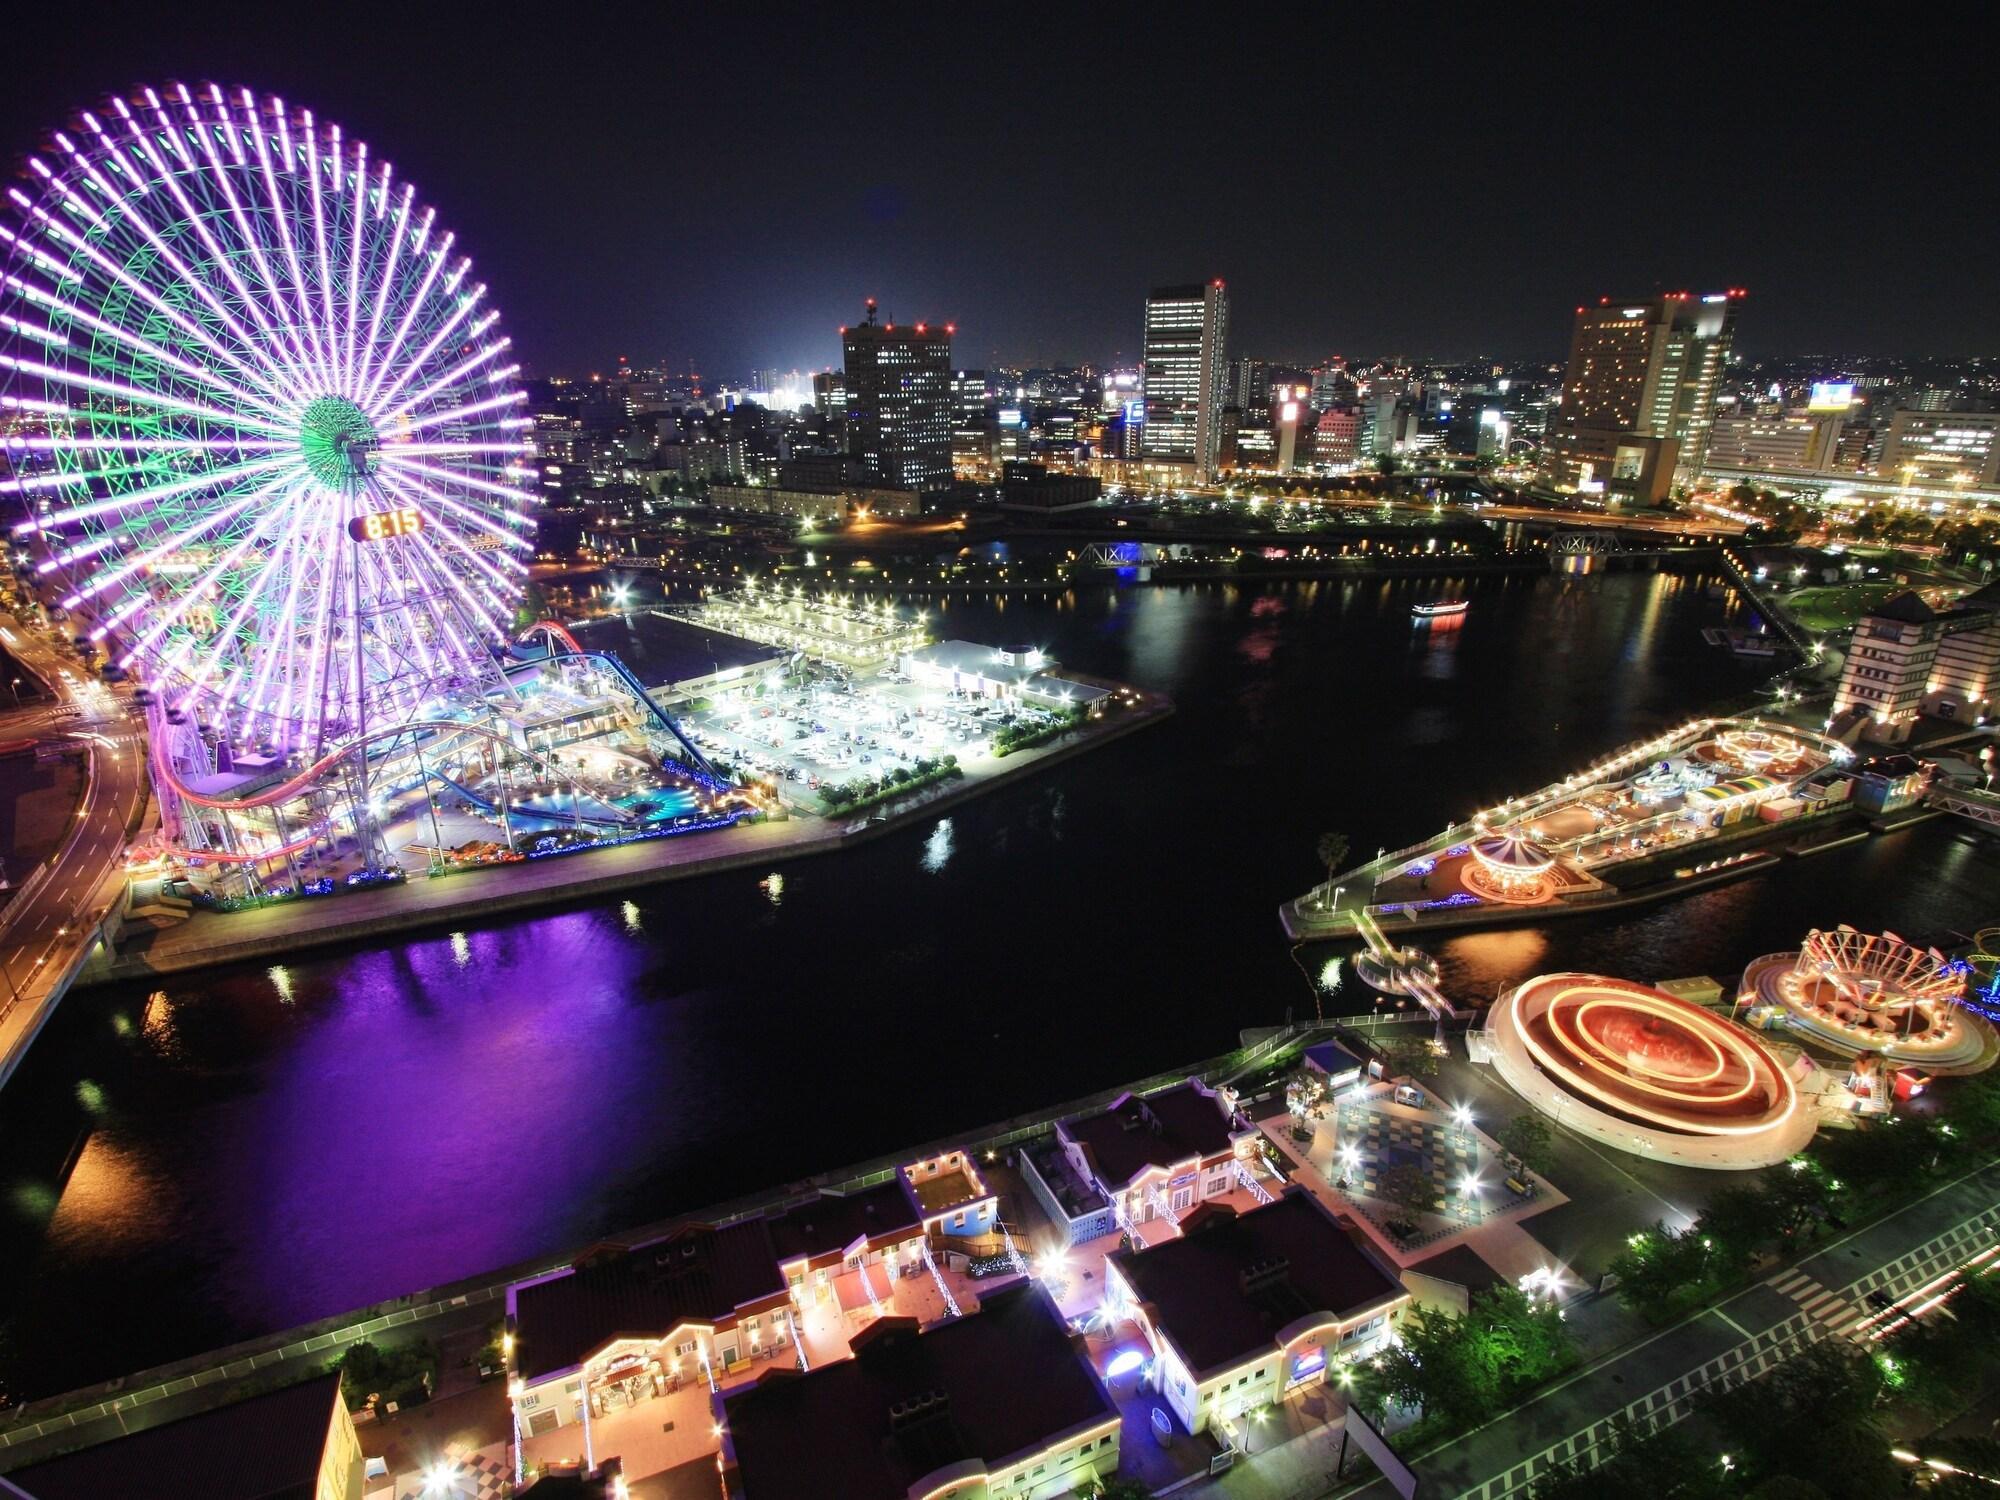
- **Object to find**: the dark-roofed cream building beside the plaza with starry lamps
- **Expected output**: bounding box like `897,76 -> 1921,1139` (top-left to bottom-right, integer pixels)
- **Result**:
1104,1186 -> 1410,1434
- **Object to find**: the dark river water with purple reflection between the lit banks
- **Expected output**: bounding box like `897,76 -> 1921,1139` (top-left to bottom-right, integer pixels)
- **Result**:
0,574 -> 2000,1394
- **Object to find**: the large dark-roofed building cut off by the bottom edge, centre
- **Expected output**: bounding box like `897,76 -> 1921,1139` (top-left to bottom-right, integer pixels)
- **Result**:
714,1282 -> 1122,1500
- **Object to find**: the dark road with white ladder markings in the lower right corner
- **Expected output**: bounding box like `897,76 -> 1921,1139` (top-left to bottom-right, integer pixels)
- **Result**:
1346,1164 -> 2000,1500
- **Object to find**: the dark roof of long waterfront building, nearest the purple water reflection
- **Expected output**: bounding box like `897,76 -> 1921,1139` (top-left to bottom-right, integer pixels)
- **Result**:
514,1218 -> 786,1382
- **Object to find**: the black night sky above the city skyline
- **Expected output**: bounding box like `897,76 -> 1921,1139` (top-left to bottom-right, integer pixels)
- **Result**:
0,0 -> 2000,378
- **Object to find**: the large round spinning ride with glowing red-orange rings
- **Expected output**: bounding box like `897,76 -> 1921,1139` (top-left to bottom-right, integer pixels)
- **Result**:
1486,974 -> 1814,1170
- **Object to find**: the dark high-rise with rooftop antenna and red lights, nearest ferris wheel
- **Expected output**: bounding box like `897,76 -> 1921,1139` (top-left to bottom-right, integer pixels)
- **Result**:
840,298 -> 956,494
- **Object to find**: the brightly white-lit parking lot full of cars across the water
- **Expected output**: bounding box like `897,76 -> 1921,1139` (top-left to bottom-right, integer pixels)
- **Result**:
680,668 -> 1054,802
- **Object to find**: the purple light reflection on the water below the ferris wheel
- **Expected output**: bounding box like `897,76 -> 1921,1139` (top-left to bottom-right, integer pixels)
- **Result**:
48,910 -> 690,1324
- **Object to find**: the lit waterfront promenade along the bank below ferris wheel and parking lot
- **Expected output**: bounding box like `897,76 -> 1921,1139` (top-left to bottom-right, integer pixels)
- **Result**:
94,692 -> 1174,984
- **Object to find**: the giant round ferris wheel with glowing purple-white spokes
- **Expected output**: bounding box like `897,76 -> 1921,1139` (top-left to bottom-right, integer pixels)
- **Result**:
0,84 -> 538,752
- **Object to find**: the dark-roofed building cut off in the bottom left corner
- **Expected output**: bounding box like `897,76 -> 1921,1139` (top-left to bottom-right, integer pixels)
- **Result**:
0,1374 -> 362,1500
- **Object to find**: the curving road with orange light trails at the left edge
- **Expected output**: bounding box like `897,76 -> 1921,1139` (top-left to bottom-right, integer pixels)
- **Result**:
0,616 -> 146,1084
